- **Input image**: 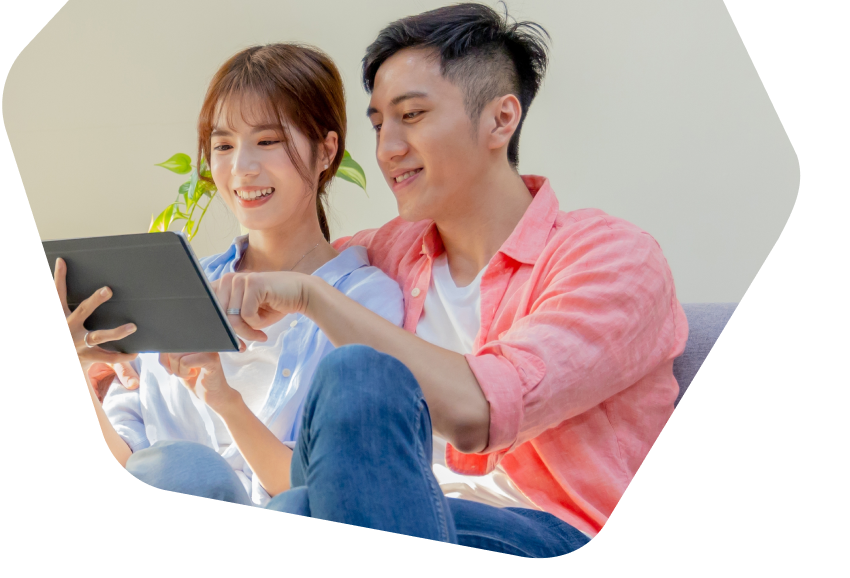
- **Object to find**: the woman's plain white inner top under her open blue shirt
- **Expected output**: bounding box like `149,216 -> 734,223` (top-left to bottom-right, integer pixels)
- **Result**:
210,317 -> 291,454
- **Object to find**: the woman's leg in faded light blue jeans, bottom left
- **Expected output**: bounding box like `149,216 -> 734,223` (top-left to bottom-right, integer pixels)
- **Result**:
127,441 -> 253,506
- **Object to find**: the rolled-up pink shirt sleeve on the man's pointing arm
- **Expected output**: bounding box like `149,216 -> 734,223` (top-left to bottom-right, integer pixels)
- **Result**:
455,221 -> 687,460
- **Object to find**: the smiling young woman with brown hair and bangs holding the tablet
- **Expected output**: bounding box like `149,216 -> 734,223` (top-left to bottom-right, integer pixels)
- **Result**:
61,44 -> 403,506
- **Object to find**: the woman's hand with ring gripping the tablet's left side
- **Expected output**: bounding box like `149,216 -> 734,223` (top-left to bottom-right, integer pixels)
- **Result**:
53,259 -> 136,376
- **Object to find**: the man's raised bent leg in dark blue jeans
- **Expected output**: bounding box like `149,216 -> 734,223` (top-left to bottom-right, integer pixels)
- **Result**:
266,345 -> 456,543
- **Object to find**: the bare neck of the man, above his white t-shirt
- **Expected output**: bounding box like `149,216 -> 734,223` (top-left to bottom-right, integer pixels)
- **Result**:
436,164 -> 533,287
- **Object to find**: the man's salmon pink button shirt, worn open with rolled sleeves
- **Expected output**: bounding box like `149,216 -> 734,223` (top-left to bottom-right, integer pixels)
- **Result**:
334,176 -> 688,536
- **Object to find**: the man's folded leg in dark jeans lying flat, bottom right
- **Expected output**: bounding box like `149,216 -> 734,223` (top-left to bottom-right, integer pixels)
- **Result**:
449,498 -> 590,558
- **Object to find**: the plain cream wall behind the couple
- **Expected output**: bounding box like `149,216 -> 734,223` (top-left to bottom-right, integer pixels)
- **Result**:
2,0 -> 800,302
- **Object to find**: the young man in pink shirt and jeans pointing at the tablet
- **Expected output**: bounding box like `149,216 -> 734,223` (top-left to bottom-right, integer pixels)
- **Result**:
99,4 -> 687,557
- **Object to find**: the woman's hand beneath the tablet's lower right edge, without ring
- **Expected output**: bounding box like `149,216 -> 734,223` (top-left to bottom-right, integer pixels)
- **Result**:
159,353 -> 242,417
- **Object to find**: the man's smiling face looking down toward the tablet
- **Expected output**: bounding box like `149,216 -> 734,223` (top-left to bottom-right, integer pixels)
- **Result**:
368,48 -> 487,222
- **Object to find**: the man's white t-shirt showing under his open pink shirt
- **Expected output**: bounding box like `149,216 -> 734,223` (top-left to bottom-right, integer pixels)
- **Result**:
416,253 -> 540,510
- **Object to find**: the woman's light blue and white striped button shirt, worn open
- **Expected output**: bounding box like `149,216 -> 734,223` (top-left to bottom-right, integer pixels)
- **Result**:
103,236 -> 404,506
